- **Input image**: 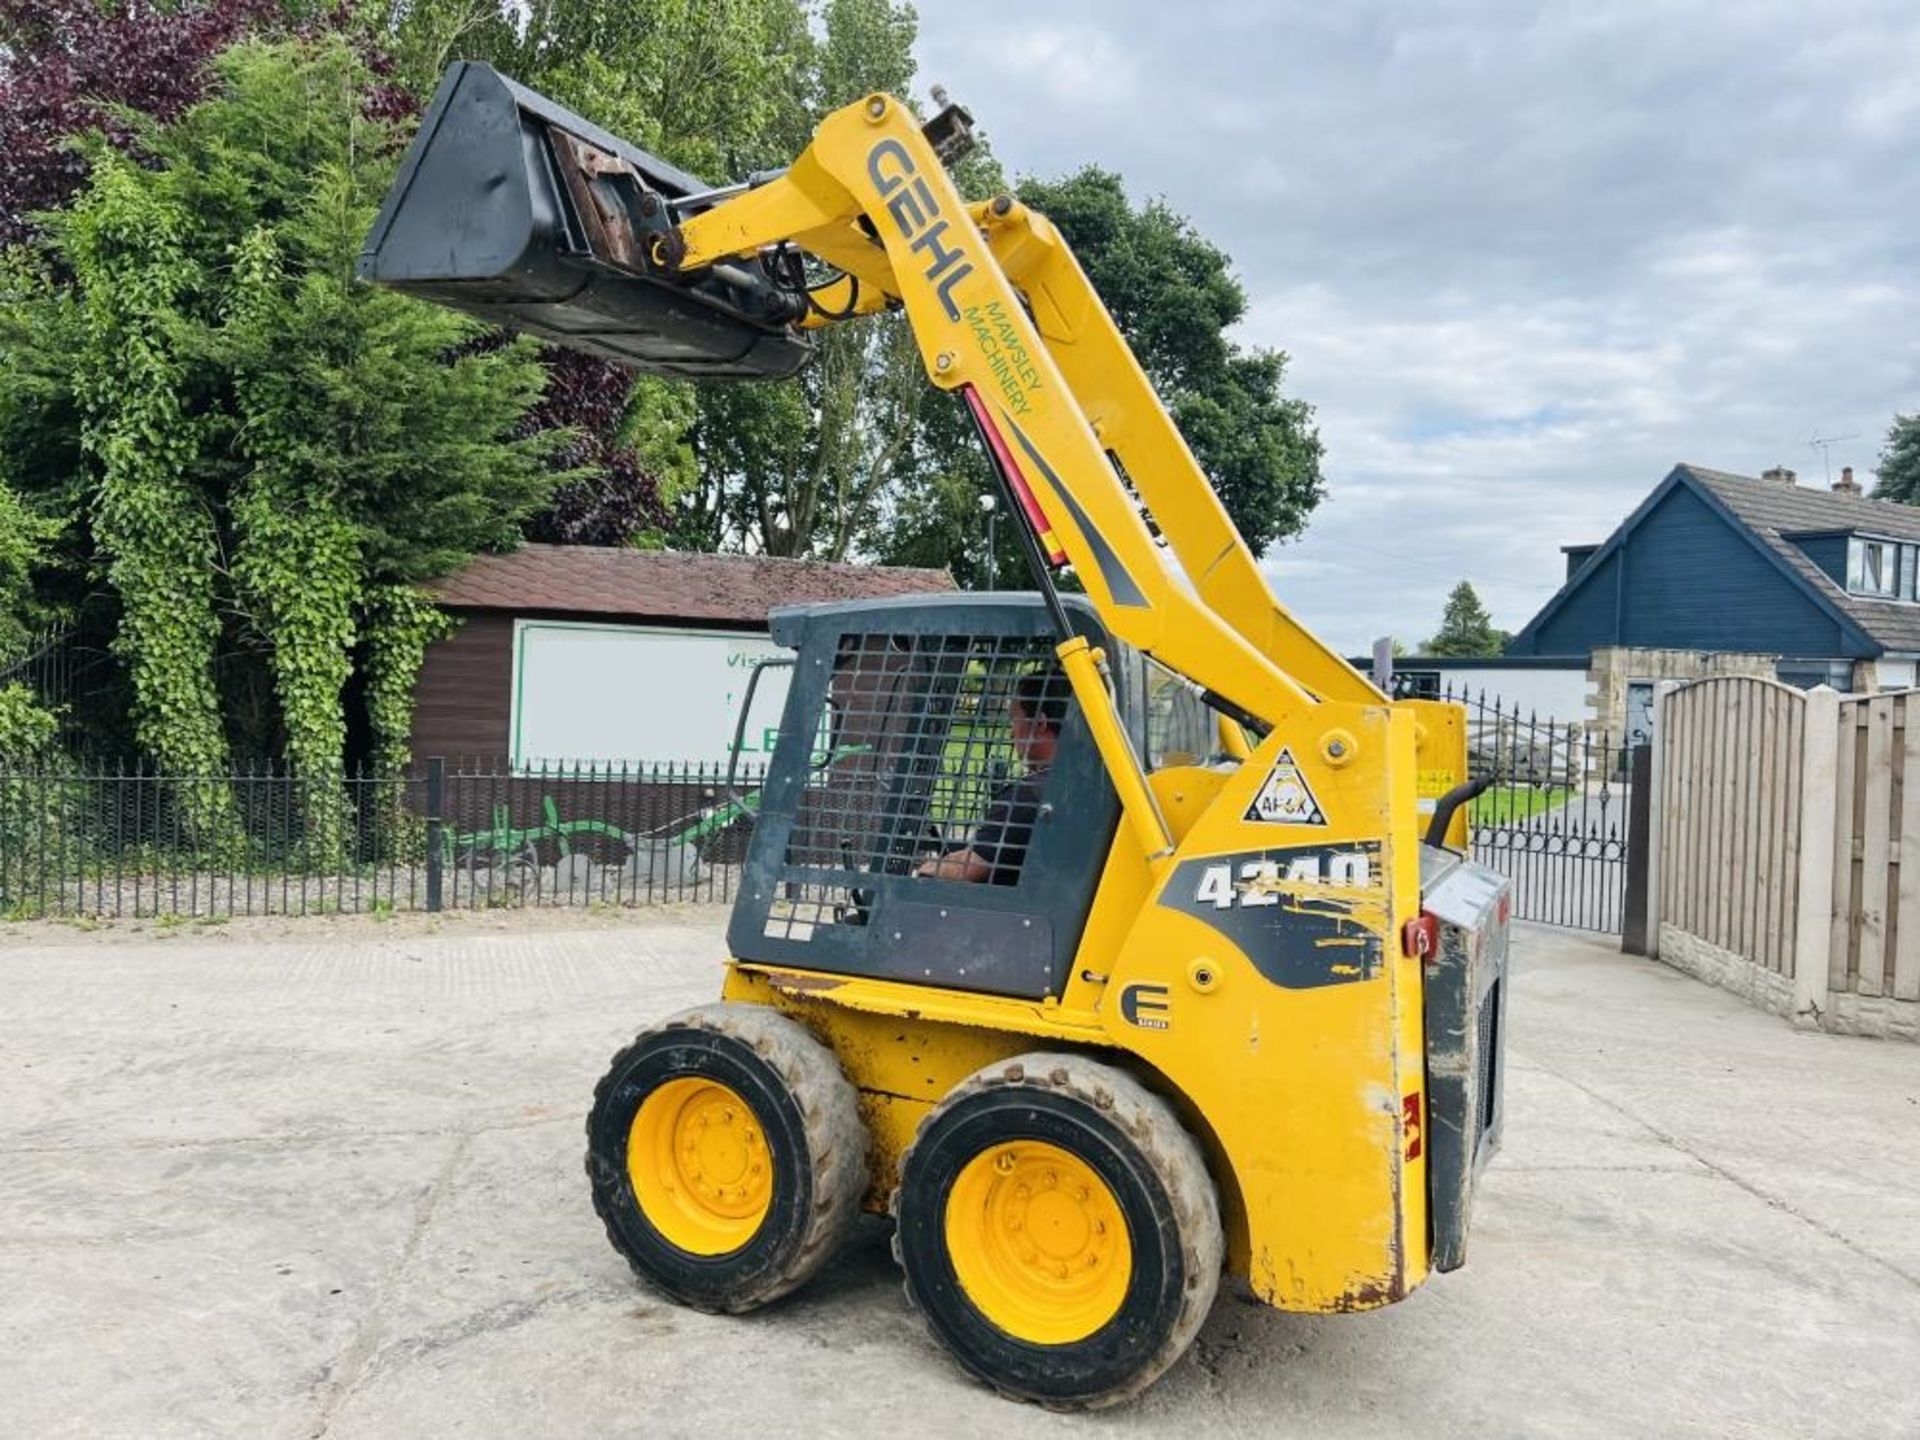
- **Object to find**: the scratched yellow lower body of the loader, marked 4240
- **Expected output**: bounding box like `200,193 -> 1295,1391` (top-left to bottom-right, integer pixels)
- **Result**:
726,705 -> 1427,1311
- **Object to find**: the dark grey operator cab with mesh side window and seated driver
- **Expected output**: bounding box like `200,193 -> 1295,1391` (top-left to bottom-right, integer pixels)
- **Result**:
728,593 -> 1182,998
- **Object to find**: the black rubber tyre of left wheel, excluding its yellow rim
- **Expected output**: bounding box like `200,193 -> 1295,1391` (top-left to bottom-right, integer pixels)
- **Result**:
588,1004 -> 868,1315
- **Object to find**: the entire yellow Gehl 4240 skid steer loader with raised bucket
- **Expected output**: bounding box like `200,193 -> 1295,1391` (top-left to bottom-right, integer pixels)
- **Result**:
361,63 -> 1507,1407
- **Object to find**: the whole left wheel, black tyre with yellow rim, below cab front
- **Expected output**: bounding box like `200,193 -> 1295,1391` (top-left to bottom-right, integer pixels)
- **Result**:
588,1004 -> 868,1313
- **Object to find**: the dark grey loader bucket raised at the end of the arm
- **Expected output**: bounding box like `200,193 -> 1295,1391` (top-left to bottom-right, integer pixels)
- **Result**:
359,61 -> 812,378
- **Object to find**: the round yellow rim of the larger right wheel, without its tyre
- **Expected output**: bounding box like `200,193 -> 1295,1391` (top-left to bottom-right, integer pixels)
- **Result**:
947,1140 -> 1133,1346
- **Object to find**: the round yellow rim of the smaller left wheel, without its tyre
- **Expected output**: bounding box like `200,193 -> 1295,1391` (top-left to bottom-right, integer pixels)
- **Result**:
626,1077 -> 774,1256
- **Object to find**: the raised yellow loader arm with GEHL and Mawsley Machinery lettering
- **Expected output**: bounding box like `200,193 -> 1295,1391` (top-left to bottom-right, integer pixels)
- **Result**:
668,94 -> 1384,726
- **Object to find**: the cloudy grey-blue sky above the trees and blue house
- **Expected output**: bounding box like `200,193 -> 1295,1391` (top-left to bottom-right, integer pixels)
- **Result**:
920,0 -> 1920,653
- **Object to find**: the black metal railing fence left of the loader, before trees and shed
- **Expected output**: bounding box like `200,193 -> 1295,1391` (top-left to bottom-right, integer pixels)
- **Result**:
0,760 -> 764,920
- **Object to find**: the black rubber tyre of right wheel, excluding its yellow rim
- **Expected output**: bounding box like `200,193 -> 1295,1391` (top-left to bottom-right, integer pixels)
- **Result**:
893,1054 -> 1225,1409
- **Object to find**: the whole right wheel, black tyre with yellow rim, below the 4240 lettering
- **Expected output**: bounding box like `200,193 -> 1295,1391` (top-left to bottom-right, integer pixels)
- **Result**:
893,1054 -> 1225,1409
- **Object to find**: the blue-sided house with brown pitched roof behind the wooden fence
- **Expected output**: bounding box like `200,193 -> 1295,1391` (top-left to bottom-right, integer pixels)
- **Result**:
1507,465 -> 1920,728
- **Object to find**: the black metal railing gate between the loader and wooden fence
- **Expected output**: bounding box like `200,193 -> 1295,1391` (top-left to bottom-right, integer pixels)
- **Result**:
1425,691 -> 1632,933
